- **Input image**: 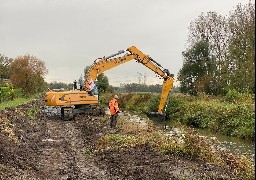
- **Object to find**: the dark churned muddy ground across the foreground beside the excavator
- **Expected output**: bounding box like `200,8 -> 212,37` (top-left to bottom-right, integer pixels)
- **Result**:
0,99 -> 243,180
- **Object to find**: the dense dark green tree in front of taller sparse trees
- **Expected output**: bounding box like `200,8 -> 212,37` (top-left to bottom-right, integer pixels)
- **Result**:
178,41 -> 214,95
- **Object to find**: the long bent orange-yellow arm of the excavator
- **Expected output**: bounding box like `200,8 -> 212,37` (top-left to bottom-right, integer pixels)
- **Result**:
85,46 -> 174,114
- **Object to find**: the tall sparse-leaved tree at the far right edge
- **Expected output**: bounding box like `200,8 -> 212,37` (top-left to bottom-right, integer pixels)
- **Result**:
228,2 -> 255,92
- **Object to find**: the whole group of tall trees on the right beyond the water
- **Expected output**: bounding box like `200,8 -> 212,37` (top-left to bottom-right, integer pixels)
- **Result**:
178,1 -> 255,95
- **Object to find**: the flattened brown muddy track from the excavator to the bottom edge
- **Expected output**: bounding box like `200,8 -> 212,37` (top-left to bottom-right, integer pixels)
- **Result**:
38,119 -> 110,179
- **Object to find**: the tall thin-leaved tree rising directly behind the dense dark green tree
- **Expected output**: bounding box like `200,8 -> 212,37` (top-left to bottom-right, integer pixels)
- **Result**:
188,12 -> 229,94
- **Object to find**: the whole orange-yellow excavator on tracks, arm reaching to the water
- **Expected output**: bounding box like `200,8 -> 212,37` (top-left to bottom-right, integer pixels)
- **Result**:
44,46 -> 174,119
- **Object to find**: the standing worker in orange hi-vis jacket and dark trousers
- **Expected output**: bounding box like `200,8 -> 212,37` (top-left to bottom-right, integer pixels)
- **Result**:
109,95 -> 120,128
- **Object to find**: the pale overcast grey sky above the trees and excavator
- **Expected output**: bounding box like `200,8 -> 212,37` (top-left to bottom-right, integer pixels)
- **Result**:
0,0 -> 249,86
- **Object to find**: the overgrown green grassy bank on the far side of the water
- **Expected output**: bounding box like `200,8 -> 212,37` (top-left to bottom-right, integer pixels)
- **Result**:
101,93 -> 255,141
